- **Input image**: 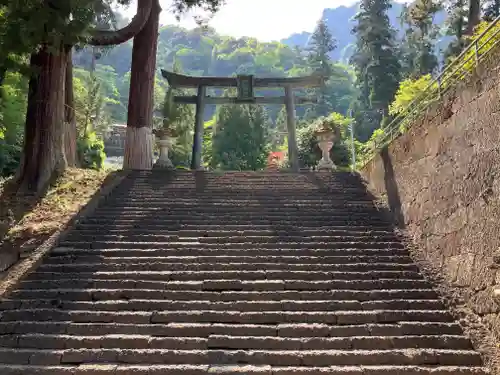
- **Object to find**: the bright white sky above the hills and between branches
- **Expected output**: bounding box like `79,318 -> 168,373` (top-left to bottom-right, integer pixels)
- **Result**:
125,0 -> 364,41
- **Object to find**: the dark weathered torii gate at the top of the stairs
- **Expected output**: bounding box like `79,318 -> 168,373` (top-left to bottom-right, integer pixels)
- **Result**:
161,70 -> 324,172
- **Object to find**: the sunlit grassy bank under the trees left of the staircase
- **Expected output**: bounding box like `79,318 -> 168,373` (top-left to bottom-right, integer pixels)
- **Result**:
0,168 -> 111,264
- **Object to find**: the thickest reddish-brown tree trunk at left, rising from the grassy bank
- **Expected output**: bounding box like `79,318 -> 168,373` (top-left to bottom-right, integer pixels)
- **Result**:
19,46 -> 68,192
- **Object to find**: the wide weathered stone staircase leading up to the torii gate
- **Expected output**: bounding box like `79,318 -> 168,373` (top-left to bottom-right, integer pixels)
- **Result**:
0,171 -> 487,375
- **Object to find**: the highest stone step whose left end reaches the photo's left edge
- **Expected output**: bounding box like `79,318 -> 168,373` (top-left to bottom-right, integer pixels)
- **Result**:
0,299 -> 443,311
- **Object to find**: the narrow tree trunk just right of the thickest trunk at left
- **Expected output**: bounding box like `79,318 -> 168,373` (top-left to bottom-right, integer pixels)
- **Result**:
63,47 -> 78,167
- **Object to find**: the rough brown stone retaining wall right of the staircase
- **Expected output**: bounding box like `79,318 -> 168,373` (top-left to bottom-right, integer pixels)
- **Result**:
361,49 -> 500,352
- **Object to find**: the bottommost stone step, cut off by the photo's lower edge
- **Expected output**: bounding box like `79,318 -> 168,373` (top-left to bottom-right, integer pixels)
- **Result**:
0,364 -> 488,375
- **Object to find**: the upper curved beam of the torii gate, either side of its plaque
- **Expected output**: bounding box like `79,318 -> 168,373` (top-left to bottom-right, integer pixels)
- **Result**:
161,69 -> 324,88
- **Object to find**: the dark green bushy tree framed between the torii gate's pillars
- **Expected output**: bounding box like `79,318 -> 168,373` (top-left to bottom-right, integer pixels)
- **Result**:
211,105 -> 269,170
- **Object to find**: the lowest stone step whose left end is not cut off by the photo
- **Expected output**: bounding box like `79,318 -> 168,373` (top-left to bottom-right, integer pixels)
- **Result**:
11,288 -> 438,302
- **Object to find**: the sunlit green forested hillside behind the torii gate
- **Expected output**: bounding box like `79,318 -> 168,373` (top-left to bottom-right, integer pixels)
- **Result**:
74,26 -> 354,122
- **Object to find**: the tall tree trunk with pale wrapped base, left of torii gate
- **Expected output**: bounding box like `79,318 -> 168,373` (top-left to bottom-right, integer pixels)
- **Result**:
123,0 -> 161,170
